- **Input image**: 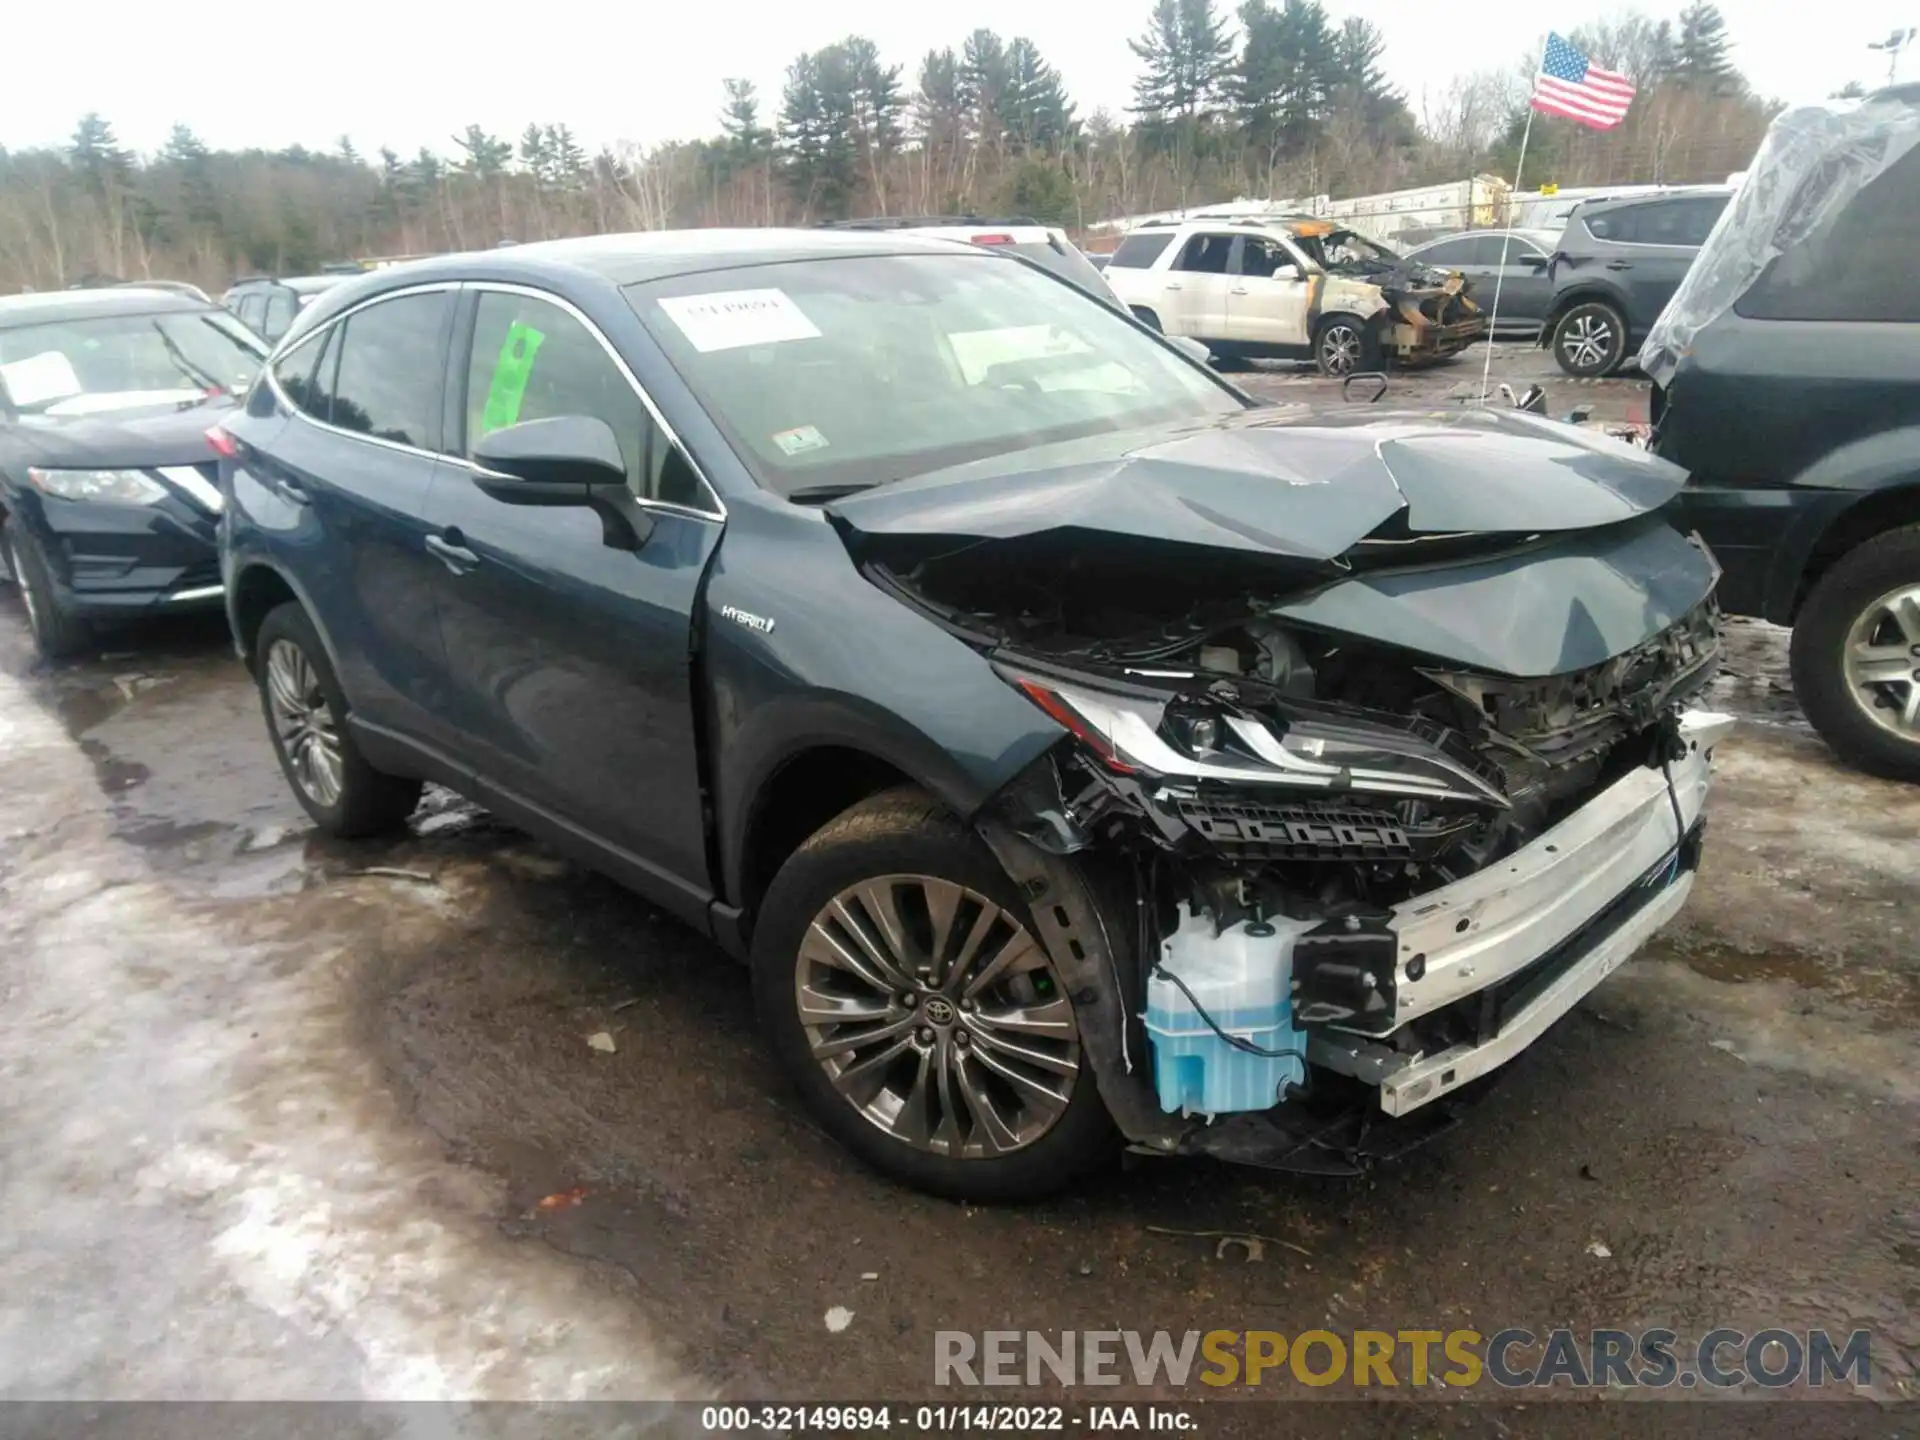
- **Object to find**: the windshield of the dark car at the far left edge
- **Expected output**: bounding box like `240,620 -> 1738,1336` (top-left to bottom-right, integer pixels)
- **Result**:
0,311 -> 265,415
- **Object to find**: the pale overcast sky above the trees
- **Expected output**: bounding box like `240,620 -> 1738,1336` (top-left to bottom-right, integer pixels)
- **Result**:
0,0 -> 1920,156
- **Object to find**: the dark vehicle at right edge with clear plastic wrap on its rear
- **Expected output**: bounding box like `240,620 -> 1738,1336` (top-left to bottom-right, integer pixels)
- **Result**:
1640,86 -> 1920,780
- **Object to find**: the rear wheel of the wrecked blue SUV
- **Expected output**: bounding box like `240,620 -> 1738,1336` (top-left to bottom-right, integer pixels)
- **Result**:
253,601 -> 420,839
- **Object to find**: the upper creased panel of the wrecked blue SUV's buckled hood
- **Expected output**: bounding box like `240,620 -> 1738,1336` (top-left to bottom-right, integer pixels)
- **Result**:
828,407 -> 1686,568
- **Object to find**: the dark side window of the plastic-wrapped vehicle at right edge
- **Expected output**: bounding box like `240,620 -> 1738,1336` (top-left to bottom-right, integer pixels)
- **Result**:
1734,150 -> 1920,323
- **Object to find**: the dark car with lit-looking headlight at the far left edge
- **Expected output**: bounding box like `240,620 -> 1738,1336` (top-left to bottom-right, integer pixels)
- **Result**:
0,290 -> 265,659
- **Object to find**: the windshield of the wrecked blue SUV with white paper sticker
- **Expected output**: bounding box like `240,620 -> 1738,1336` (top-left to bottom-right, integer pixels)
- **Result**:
628,252 -> 1244,499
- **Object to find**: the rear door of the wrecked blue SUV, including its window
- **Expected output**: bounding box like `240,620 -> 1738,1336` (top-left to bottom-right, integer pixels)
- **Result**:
234,286 -> 453,737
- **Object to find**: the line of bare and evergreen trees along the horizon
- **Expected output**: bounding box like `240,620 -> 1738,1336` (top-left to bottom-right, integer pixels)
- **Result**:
0,0 -> 1776,292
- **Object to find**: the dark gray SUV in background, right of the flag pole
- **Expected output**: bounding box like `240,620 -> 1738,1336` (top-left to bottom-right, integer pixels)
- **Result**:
1540,188 -> 1732,378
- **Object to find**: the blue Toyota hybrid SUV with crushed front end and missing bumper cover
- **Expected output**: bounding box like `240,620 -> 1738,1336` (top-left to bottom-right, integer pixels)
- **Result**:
219,230 -> 1728,1198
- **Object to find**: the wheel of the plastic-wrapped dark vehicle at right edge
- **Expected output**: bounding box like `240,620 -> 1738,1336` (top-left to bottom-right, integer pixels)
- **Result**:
1789,526 -> 1920,781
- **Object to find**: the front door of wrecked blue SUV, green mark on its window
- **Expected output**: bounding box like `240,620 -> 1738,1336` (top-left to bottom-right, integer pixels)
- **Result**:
428,290 -> 720,895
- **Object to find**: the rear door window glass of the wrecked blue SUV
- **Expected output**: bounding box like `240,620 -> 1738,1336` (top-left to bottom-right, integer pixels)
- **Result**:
328,290 -> 453,449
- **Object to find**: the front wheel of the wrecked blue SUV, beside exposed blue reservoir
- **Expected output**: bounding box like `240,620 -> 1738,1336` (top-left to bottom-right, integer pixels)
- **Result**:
753,789 -> 1114,1200
